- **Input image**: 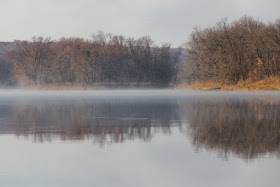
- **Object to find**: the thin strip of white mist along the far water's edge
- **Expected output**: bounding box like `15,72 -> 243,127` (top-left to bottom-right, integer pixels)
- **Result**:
0,88 -> 280,99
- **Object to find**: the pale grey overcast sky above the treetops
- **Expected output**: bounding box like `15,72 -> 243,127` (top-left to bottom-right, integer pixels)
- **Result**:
0,0 -> 280,47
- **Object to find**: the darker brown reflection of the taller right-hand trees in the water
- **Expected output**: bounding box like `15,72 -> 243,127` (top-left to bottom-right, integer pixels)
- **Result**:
180,96 -> 280,160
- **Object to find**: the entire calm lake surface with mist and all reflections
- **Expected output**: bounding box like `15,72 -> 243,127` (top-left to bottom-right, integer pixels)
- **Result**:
0,90 -> 280,187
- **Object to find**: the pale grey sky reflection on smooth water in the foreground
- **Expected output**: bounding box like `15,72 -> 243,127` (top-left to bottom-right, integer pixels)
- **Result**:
0,132 -> 280,187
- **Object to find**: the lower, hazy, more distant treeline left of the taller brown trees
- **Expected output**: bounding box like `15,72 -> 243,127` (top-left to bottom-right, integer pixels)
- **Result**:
7,32 -> 181,86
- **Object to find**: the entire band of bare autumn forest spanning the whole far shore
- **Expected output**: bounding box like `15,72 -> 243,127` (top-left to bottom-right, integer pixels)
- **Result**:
0,16 -> 280,89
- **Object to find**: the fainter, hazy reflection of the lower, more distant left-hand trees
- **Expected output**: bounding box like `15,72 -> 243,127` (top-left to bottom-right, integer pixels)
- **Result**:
0,100 -> 181,146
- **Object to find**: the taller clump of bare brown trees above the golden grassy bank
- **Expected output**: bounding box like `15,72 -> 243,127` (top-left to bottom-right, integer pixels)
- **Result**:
182,16 -> 280,84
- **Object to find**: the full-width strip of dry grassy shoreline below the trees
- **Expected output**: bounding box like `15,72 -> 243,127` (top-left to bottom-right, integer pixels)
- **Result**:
0,77 -> 280,91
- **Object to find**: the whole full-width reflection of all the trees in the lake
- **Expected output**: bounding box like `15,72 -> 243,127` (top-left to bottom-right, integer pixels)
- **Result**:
0,95 -> 280,160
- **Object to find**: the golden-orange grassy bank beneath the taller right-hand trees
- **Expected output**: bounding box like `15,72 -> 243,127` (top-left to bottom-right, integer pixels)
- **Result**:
174,77 -> 280,90
